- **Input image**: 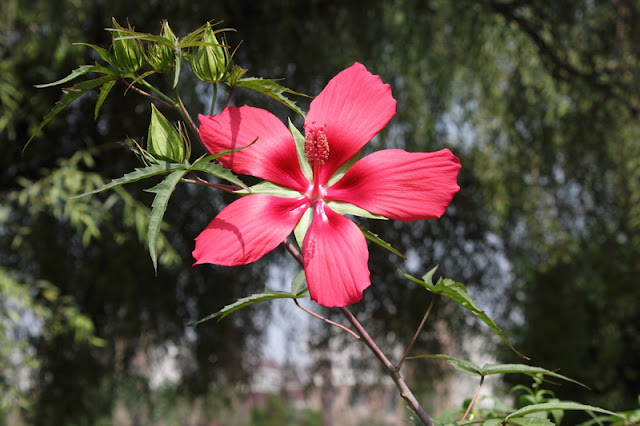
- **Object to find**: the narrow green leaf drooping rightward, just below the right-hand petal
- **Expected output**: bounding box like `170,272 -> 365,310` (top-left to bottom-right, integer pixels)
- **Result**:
400,266 -> 529,359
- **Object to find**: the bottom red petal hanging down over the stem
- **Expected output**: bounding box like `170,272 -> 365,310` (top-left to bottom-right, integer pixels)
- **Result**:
302,202 -> 371,307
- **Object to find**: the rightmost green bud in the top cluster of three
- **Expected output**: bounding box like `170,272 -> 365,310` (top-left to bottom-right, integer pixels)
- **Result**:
191,26 -> 229,83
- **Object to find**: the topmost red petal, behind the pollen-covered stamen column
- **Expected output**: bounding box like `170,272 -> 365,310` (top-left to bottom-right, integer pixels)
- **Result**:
305,63 -> 396,185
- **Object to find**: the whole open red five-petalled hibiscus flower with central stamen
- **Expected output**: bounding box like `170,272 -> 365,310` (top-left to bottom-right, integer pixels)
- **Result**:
193,63 -> 460,307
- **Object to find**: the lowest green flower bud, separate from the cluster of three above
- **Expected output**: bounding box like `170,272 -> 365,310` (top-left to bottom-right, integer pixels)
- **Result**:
147,104 -> 191,163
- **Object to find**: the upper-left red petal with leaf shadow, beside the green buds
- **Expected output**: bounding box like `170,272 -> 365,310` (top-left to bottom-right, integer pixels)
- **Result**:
199,106 -> 309,192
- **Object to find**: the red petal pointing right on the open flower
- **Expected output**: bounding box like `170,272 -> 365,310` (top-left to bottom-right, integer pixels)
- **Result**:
326,149 -> 460,221
